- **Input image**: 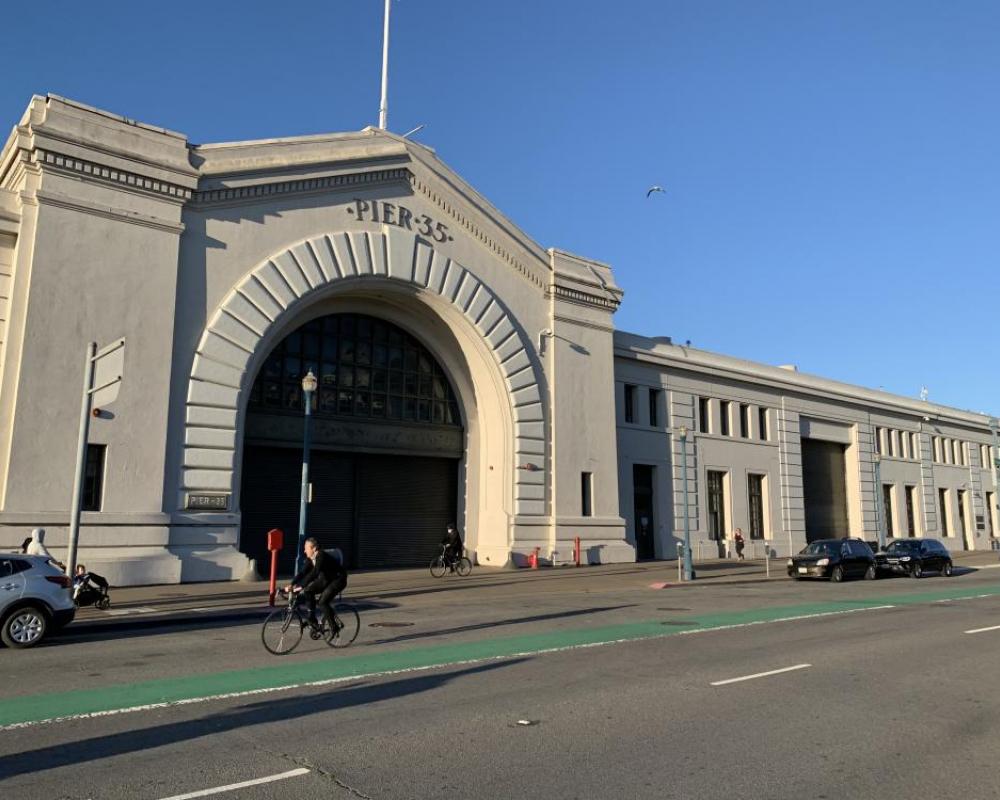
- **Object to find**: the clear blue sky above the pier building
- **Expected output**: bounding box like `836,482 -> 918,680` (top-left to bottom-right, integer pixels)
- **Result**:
7,0 -> 1000,413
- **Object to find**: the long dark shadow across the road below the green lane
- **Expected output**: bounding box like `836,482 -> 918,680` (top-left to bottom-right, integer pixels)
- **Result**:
0,658 -> 528,780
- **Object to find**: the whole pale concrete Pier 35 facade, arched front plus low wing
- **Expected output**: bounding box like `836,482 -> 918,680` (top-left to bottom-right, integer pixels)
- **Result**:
0,96 -> 998,585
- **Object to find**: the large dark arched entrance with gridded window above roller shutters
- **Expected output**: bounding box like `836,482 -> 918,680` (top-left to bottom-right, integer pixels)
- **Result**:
240,313 -> 464,571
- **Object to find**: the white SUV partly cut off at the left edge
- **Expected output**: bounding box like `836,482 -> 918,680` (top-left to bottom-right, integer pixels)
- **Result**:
0,553 -> 76,648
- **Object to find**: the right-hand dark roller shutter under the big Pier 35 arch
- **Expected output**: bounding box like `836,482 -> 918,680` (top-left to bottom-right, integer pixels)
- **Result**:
357,456 -> 458,567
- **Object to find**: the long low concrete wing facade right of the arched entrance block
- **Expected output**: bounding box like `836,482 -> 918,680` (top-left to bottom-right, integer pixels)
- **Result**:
615,332 -> 1000,558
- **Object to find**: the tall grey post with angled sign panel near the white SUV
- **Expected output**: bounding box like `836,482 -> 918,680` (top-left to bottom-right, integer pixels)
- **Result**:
66,339 -> 125,578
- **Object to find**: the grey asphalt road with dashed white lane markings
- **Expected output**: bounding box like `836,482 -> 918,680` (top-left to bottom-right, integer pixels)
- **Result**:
0,570 -> 1000,800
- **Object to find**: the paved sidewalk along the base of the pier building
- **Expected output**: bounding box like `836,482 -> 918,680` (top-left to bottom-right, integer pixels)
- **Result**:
72,550 -> 1000,630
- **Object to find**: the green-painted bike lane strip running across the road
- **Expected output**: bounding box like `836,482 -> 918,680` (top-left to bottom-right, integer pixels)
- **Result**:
0,581 -> 1000,731
